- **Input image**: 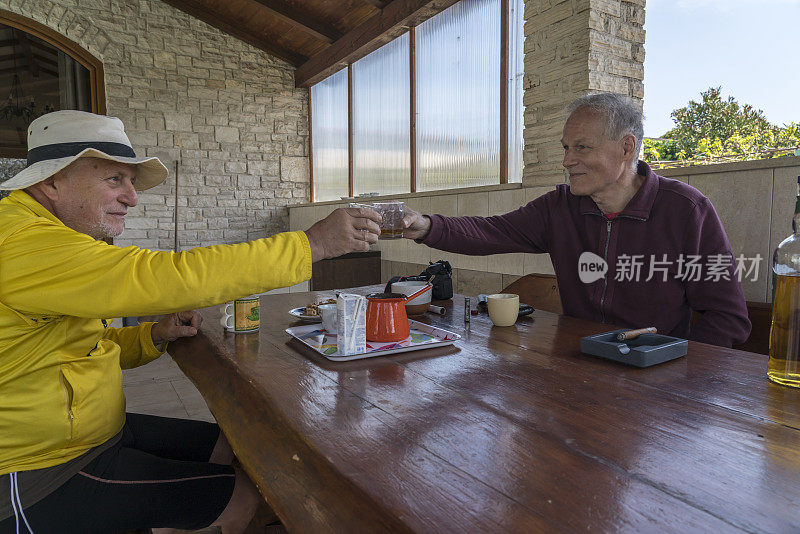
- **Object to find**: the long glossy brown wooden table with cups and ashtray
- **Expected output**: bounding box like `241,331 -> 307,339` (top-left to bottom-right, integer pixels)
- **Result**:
170,290 -> 800,533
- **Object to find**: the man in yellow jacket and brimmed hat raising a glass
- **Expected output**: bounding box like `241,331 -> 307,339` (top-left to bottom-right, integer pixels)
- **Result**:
0,111 -> 380,534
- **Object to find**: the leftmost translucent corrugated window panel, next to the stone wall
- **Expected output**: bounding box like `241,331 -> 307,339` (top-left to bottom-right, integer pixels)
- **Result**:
311,69 -> 348,201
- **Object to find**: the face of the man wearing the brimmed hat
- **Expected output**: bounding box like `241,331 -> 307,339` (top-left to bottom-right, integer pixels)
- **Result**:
53,158 -> 139,239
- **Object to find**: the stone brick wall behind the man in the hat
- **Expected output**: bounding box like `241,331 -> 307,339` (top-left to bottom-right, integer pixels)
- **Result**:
0,0 -> 309,250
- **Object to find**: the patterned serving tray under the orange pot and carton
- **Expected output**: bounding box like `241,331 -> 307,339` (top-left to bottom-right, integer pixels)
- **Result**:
285,319 -> 461,362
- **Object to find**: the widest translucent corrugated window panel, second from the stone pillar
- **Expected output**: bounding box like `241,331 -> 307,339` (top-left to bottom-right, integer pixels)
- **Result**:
416,0 -> 500,191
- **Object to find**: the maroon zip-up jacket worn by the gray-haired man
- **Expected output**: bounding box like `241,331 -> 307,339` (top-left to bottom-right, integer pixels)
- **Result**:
421,161 -> 752,347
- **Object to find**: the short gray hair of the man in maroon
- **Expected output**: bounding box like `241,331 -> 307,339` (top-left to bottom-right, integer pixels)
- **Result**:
564,93 -> 644,171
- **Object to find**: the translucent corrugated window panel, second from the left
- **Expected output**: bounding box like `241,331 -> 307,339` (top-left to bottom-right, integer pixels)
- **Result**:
353,33 -> 411,194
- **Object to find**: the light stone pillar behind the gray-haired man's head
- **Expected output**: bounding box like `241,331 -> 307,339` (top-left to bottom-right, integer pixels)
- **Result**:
522,0 -> 645,186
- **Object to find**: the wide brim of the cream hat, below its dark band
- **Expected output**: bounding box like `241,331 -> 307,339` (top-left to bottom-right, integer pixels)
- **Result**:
0,148 -> 169,191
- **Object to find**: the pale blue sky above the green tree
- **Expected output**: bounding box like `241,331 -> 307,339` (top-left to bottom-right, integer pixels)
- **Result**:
644,0 -> 800,137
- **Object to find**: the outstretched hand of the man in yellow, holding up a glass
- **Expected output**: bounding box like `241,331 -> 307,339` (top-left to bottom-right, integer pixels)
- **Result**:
306,208 -> 381,261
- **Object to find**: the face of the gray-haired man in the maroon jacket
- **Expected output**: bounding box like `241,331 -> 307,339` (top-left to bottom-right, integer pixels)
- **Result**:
561,110 -> 630,197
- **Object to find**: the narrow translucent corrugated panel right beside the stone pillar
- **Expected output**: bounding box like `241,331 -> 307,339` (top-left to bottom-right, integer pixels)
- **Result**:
508,0 -> 525,182
